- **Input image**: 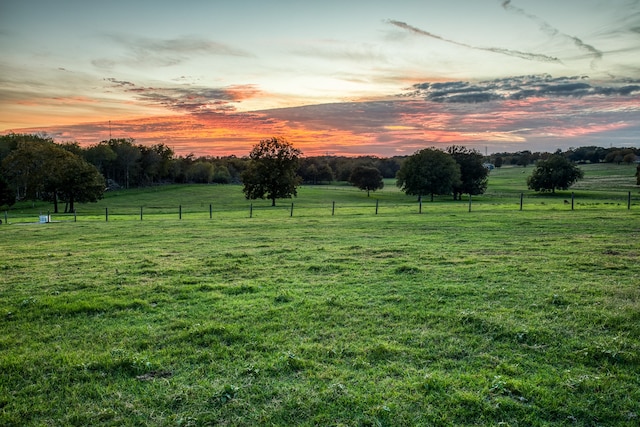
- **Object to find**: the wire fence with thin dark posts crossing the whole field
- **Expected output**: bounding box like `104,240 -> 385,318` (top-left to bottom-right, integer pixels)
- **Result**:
0,192 -> 640,224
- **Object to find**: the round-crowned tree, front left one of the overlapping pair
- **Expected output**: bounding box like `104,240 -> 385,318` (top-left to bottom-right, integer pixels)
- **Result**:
396,148 -> 460,201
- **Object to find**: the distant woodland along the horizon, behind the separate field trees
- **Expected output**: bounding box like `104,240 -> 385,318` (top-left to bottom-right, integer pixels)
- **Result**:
0,133 -> 640,189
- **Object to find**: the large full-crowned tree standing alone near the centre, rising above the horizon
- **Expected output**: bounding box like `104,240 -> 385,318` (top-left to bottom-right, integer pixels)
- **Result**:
242,138 -> 302,206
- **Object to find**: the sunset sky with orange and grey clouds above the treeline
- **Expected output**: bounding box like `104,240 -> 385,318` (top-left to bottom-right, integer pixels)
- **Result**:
0,0 -> 640,157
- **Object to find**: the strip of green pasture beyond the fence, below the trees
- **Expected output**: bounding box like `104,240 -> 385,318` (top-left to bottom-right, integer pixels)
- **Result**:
0,164 -> 640,223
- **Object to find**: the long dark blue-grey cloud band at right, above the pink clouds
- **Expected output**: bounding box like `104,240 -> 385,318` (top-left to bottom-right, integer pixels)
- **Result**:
407,75 -> 640,103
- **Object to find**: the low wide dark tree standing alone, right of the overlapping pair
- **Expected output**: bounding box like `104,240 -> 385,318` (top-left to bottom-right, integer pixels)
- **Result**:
527,151 -> 584,193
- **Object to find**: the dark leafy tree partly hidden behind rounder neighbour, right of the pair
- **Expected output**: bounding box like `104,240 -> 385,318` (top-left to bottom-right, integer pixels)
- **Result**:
447,145 -> 489,200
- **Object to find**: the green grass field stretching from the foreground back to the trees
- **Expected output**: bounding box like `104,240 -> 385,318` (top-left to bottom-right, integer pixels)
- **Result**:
0,163 -> 640,426
